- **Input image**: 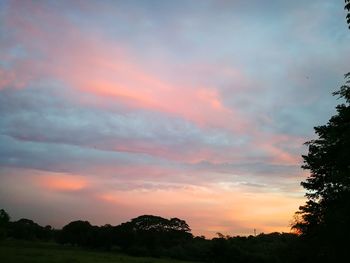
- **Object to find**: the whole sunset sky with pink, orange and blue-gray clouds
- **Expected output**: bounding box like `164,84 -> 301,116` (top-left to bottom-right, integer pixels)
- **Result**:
0,0 -> 350,237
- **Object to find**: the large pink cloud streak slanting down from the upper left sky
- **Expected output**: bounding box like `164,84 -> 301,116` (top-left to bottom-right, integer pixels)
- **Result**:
2,0 -> 247,134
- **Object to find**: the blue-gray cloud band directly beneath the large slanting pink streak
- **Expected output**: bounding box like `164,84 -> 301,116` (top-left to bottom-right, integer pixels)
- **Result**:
0,86 -> 252,163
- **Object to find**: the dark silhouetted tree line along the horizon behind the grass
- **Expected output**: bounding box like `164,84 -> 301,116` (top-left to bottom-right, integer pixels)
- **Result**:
0,209 -> 297,263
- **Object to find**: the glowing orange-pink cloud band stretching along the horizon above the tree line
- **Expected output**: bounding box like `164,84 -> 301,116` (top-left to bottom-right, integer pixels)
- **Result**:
0,168 -> 305,237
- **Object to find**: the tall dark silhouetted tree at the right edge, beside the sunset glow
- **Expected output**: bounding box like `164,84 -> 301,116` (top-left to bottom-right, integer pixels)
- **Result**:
293,73 -> 350,260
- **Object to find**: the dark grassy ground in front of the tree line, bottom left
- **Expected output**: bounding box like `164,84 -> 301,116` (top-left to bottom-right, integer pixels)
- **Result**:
0,240 -> 191,263
